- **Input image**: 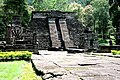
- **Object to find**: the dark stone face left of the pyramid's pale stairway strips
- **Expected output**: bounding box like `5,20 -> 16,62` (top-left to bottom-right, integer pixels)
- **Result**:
30,18 -> 50,49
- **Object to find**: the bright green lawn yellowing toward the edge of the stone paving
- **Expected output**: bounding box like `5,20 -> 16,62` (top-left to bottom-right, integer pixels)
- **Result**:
0,61 -> 42,80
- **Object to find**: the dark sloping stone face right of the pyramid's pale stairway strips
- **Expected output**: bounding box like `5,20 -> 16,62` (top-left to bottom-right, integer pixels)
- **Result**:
66,18 -> 85,48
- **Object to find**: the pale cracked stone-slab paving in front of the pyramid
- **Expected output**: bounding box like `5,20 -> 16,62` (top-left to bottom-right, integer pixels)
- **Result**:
32,51 -> 120,80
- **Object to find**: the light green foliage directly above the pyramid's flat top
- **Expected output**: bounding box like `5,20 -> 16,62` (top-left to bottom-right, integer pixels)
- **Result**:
33,0 -> 68,11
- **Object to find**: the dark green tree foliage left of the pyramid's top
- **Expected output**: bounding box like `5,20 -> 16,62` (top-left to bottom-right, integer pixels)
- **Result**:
2,0 -> 29,27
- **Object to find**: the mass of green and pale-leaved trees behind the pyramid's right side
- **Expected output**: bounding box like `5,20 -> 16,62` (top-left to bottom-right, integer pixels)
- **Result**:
68,0 -> 114,39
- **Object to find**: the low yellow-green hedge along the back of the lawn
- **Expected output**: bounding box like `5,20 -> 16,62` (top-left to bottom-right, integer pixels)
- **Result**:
0,51 -> 32,60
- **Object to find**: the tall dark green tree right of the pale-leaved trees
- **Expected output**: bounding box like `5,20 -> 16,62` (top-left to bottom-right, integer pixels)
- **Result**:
91,0 -> 109,38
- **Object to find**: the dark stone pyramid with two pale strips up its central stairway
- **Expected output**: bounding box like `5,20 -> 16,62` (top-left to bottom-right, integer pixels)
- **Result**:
29,10 -> 97,49
